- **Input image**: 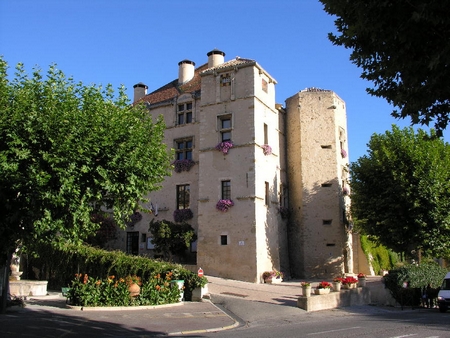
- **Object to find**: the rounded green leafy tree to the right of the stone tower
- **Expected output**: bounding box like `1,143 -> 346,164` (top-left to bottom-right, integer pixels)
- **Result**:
350,125 -> 450,257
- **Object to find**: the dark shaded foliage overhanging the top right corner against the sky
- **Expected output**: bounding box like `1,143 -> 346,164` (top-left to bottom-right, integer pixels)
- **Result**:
320,0 -> 450,136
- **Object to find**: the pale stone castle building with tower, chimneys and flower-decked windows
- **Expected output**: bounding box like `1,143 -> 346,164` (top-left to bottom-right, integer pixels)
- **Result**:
111,50 -> 353,283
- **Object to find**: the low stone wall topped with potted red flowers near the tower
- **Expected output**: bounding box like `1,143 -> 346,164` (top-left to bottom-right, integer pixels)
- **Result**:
297,287 -> 371,311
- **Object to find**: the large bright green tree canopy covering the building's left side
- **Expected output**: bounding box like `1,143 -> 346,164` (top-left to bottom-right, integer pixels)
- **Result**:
0,58 -> 171,254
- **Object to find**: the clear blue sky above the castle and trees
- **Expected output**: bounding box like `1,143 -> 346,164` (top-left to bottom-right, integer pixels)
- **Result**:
0,0 -> 447,161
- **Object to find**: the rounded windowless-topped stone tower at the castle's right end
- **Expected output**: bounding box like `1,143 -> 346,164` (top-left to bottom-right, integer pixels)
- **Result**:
286,90 -> 353,278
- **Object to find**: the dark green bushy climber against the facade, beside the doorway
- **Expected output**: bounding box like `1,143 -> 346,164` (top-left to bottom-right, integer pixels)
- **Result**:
149,219 -> 197,262
